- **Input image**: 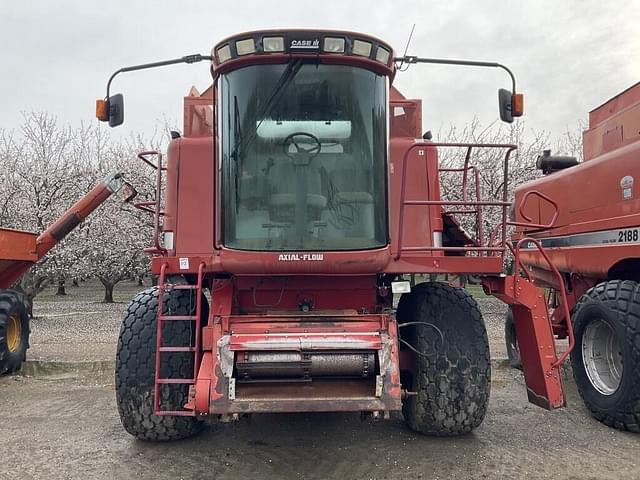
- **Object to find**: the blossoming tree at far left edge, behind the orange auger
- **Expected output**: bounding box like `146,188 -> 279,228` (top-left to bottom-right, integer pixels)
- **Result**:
0,112 -> 87,303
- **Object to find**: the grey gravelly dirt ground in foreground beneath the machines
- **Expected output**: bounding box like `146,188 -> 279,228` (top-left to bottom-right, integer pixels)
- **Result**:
0,368 -> 640,480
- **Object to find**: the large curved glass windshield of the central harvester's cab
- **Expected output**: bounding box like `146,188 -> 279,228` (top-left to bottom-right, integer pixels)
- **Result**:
219,60 -> 387,251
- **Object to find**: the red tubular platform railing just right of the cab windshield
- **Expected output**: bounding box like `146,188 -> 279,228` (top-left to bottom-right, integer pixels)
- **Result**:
394,142 -> 517,260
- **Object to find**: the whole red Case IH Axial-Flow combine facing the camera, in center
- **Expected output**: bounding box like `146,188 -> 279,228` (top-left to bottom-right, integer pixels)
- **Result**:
96,30 -> 570,440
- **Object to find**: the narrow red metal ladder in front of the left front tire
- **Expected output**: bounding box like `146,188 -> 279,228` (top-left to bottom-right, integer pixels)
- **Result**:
153,263 -> 205,417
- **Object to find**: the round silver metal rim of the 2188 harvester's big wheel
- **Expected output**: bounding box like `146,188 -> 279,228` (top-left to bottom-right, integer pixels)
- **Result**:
582,319 -> 623,395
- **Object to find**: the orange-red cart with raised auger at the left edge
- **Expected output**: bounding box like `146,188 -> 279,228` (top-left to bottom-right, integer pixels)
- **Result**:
0,173 -> 135,375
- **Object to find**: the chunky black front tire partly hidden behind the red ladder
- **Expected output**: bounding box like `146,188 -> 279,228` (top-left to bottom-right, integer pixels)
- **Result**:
116,287 -> 208,441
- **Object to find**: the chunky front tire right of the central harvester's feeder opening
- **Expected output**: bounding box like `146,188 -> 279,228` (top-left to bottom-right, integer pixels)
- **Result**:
397,283 -> 491,436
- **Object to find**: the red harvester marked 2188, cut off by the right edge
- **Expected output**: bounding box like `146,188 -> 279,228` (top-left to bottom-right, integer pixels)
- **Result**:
506,83 -> 640,432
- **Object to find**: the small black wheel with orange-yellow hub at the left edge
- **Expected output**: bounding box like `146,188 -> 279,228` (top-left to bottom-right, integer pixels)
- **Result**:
0,290 -> 30,374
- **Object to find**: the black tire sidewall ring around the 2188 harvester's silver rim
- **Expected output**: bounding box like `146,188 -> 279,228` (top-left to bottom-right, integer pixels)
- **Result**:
571,298 -> 633,412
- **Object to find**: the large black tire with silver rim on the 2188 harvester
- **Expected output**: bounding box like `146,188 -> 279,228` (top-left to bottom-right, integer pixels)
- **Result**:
571,280 -> 640,432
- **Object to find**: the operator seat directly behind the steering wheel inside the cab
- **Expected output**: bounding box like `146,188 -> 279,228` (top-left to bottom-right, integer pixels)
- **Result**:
268,158 -> 327,222
